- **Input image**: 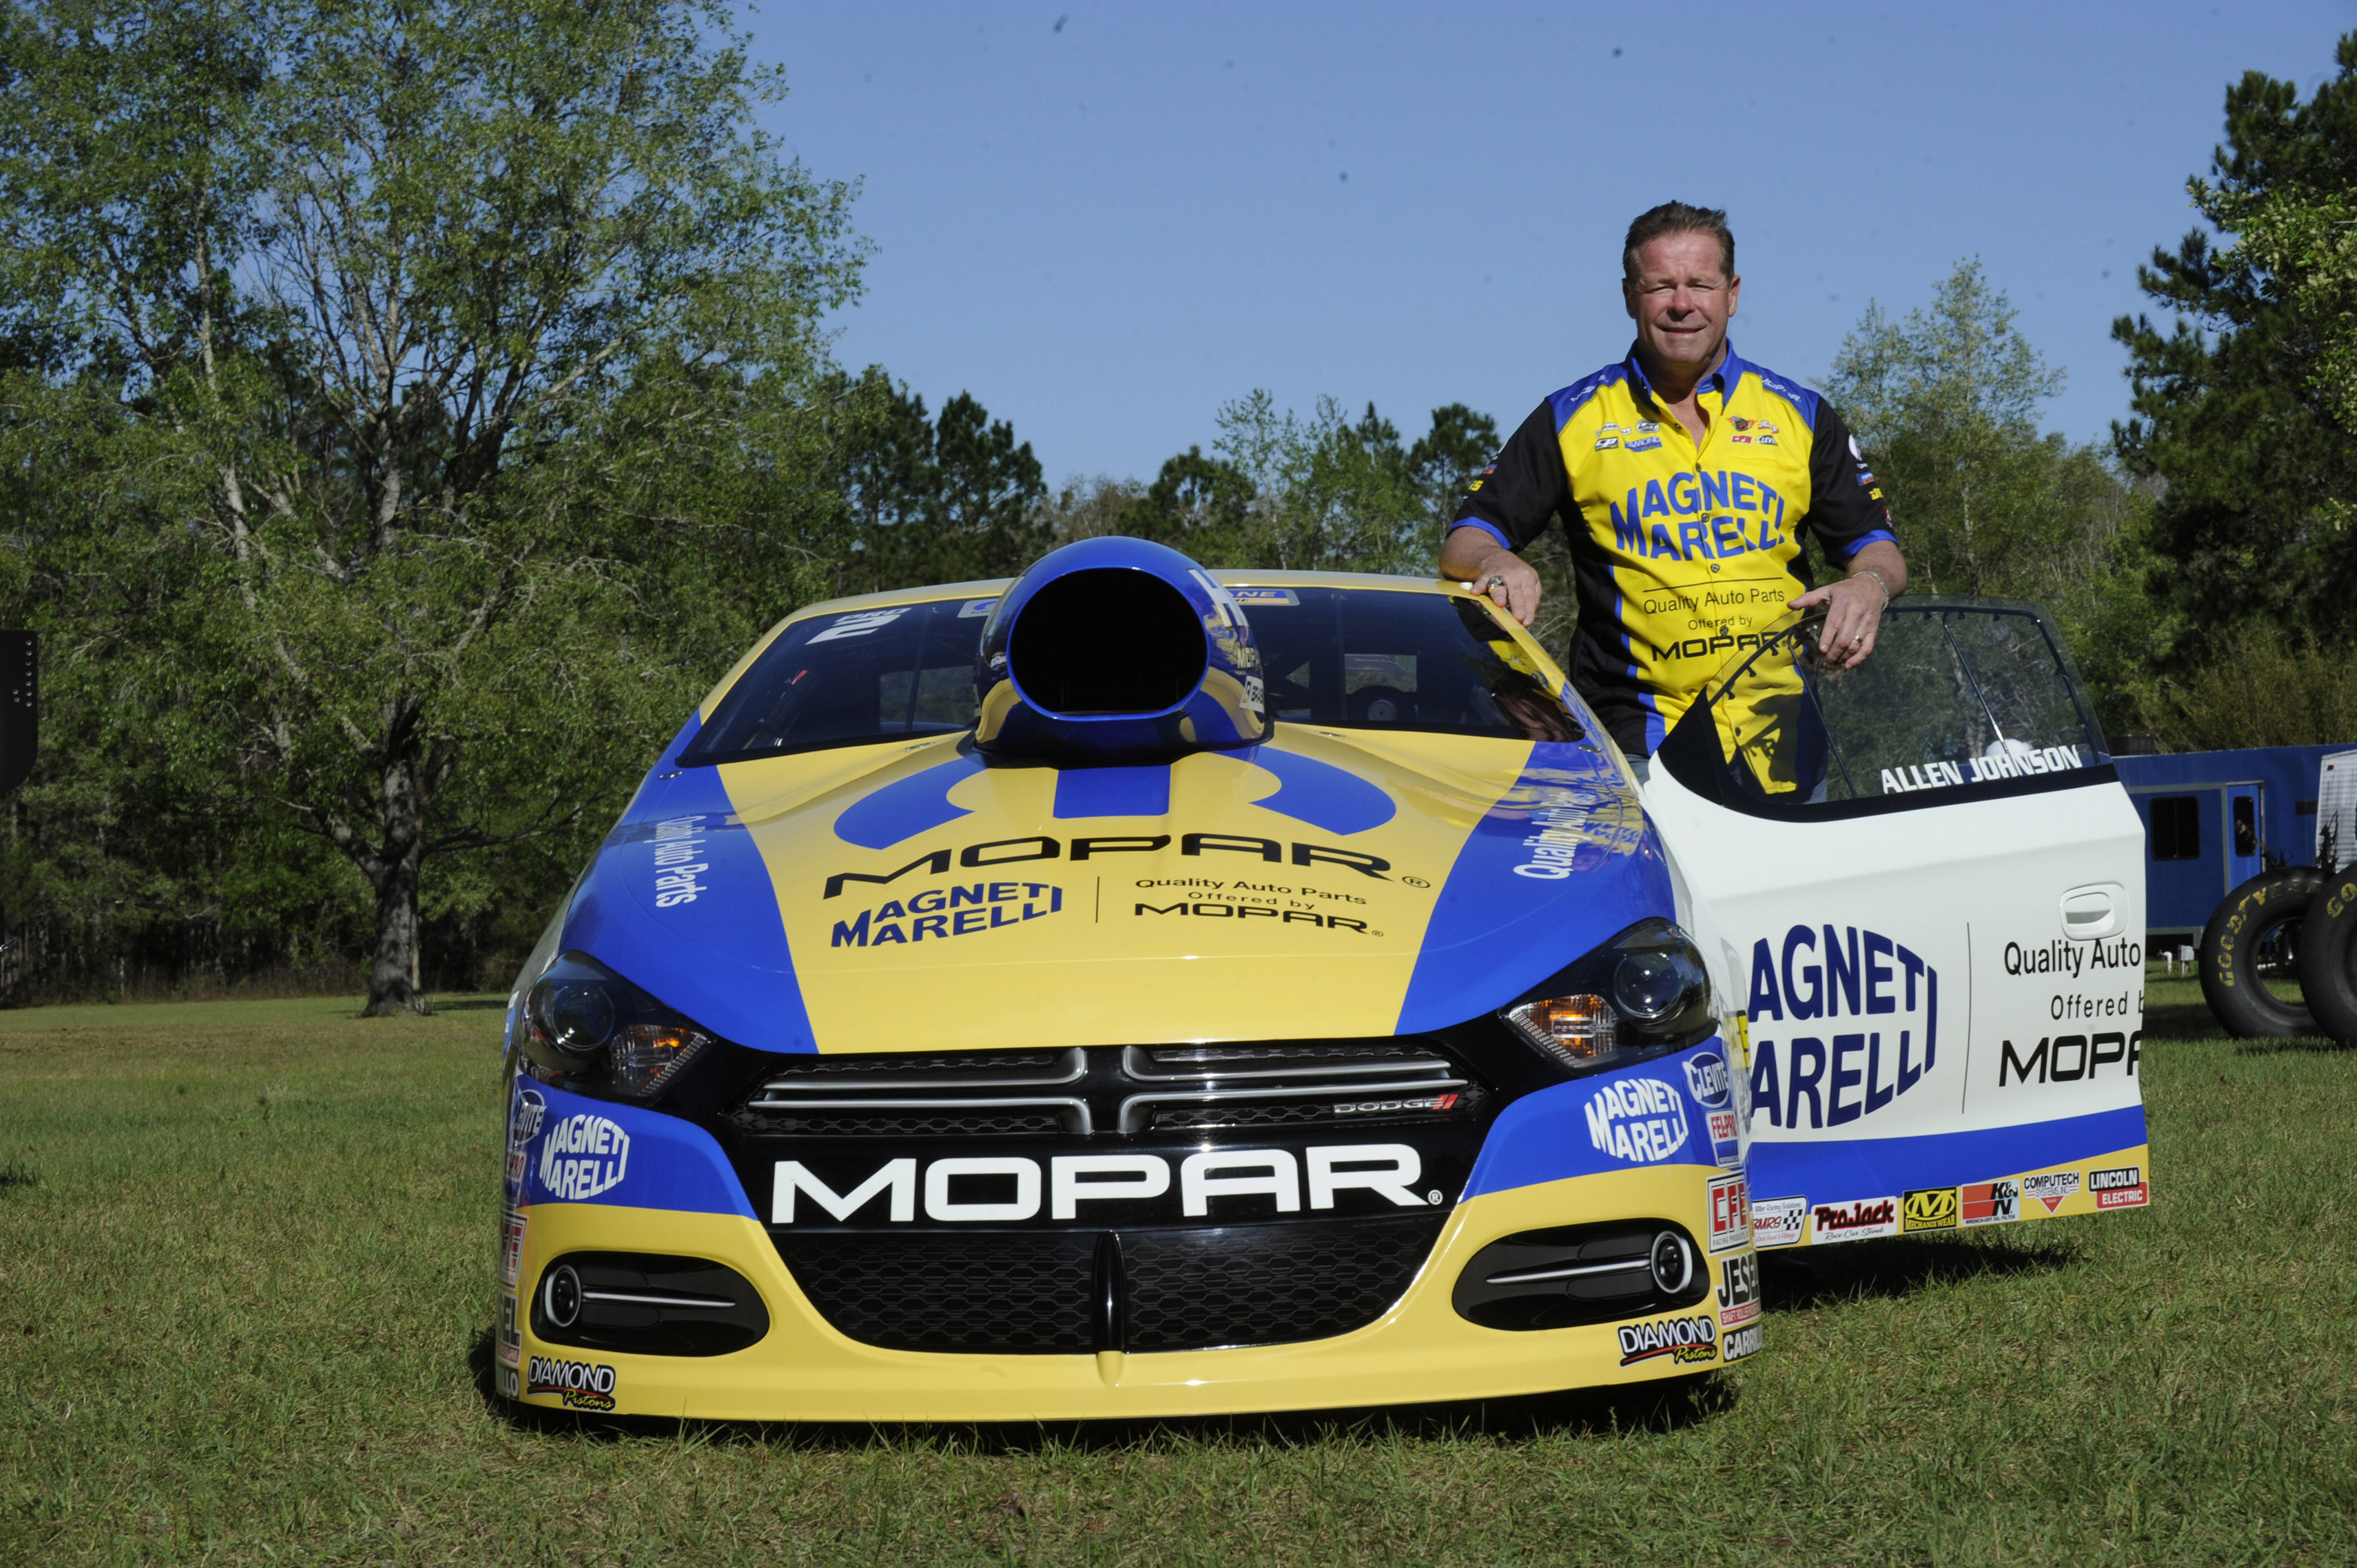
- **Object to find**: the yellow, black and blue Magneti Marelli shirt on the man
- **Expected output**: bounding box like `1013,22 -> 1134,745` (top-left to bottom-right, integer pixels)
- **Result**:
1452,344 -> 1893,757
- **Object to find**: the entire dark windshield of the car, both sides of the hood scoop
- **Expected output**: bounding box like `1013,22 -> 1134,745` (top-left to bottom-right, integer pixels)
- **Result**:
679,587 -> 1582,766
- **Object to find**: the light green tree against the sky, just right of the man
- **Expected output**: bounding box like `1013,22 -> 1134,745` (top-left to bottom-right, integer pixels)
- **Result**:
1827,259 -> 2159,724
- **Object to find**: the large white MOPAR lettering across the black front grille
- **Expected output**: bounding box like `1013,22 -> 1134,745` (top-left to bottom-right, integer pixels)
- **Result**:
768,1144 -> 1447,1226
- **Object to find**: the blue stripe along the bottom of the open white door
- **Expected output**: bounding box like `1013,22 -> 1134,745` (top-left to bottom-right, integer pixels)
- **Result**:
1751,1106 -> 2147,1203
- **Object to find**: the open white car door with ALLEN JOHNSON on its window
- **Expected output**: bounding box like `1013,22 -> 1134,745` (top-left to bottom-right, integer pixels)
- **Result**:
1645,599 -> 2150,1247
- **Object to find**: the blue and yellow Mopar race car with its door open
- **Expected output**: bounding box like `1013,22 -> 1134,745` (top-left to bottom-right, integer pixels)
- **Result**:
497,537 -> 2150,1422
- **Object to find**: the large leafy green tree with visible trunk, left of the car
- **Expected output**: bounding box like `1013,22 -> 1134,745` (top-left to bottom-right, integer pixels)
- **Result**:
0,0 -> 858,1012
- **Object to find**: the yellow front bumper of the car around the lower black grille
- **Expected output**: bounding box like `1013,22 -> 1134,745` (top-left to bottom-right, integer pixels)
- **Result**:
502,1165 -> 1758,1422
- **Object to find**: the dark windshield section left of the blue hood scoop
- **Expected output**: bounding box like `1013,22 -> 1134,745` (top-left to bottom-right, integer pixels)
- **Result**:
679,599 -> 997,766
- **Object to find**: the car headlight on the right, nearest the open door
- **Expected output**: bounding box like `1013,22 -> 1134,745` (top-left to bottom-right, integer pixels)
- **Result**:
1499,920 -> 1718,1071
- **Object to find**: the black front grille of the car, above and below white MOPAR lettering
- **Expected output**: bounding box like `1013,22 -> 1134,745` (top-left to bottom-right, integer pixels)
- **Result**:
724,1038 -> 1492,1354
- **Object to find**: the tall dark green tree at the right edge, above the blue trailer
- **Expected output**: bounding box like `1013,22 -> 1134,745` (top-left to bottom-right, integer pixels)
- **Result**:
2112,33 -> 2357,655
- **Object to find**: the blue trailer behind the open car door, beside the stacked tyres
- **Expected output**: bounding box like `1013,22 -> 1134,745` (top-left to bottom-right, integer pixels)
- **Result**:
2112,742 -> 2357,951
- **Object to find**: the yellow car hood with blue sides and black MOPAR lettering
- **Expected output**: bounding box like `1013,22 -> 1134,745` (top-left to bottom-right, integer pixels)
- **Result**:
561,719 -> 1673,1052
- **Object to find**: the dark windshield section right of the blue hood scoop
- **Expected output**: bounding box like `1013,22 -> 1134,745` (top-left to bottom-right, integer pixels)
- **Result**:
1235,587 -> 1582,740
